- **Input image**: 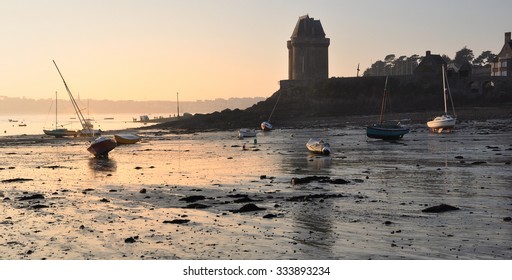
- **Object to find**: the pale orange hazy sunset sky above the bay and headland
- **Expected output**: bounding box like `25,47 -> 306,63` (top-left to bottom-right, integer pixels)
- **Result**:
0,0 -> 512,101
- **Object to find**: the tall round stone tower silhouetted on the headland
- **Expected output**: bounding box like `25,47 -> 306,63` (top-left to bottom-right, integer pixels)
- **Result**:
287,15 -> 330,80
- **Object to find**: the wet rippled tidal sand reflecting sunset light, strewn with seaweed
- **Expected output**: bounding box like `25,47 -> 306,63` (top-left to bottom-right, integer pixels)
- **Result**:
0,119 -> 512,260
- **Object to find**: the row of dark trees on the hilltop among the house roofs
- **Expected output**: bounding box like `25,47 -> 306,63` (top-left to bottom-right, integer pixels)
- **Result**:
363,47 -> 496,77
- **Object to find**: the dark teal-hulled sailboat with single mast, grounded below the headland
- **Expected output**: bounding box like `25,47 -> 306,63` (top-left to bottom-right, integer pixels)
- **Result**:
366,76 -> 409,140
